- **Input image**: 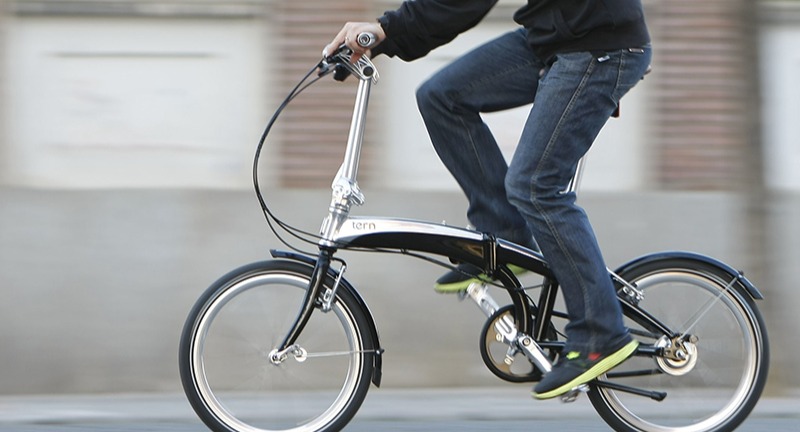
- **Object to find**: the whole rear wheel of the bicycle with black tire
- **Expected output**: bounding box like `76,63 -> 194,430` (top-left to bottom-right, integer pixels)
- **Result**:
589,258 -> 769,432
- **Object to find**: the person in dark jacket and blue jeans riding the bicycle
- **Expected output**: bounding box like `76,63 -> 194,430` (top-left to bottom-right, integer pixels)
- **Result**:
325,0 -> 652,399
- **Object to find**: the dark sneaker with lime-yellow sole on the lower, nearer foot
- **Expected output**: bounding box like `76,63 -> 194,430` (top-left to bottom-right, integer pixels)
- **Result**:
531,340 -> 639,399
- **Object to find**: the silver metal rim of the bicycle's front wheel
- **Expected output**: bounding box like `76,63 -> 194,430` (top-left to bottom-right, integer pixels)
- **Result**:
191,273 -> 362,432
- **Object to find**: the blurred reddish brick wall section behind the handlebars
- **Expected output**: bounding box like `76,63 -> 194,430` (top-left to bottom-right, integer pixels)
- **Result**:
275,0 -> 375,187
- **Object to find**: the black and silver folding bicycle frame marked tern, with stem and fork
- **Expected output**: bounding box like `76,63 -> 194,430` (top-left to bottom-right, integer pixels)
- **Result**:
275,50 -> 760,388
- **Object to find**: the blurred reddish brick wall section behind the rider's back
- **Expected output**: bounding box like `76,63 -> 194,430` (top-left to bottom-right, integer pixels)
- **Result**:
648,0 -> 757,190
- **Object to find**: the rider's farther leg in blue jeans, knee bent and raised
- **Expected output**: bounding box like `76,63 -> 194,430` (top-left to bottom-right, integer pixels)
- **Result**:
417,30 -> 544,247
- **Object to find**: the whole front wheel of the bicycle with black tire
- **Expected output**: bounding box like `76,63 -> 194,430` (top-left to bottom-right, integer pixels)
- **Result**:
179,260 -> 377,432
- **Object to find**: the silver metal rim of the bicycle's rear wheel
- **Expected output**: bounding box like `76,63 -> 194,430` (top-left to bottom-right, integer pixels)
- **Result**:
598,270 -> 762,432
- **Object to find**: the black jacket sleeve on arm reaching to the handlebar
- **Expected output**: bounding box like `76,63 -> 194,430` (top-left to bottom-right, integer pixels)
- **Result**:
372,0 -> 497,61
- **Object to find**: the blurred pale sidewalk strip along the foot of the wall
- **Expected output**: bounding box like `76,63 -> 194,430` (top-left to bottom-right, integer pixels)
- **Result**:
0,386 -> 800,430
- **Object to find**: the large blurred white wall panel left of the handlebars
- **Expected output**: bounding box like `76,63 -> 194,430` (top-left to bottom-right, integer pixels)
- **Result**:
0,13 -> 274,188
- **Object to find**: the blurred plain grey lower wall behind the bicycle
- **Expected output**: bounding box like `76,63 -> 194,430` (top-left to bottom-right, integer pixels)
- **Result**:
0,185 -> 800,394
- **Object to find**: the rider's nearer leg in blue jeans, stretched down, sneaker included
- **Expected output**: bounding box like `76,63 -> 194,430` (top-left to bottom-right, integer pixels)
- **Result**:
506,49 -> 650,398
